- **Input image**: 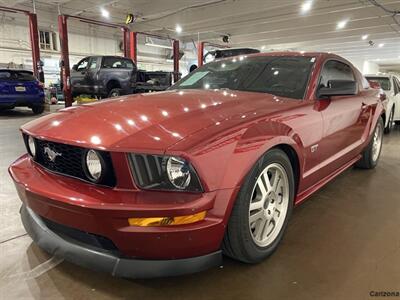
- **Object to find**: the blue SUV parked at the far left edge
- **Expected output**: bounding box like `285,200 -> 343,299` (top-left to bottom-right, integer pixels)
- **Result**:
0,69 -> 44,114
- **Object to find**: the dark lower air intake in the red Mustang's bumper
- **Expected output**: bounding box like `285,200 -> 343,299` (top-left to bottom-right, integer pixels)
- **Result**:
41,217 -> 119,253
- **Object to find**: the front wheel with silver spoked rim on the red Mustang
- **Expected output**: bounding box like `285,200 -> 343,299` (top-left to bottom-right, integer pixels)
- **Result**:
222,149 -> 295,263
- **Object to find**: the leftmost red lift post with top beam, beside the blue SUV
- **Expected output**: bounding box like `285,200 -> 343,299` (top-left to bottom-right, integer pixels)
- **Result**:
0,6 -> 44,82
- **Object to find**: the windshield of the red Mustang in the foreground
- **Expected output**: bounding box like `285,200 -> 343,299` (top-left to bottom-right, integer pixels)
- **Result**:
171,56 -> 315,99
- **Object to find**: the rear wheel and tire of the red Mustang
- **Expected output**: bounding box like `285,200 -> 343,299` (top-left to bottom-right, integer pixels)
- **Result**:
356,118 -> 385,169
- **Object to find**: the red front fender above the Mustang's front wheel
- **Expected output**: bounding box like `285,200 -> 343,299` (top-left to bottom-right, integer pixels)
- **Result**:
167,121 -> 303,191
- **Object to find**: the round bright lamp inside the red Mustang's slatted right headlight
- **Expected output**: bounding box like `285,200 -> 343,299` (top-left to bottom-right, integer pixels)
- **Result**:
167,157 -> 191,190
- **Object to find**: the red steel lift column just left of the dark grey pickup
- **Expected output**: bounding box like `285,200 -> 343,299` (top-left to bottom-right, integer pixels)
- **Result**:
58,15 -> 72,107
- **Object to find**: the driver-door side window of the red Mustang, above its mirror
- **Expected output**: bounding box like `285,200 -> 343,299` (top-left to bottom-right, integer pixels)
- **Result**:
319,60 -> 356,87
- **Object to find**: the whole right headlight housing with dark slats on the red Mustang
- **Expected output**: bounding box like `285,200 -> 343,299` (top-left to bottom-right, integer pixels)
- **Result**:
129,153 -> 203,192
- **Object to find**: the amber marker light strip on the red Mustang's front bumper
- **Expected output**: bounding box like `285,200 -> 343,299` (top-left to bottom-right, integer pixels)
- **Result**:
128,211 -> 206,226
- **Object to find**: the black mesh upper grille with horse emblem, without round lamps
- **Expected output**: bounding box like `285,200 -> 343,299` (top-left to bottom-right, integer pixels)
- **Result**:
25,137 -> 116,187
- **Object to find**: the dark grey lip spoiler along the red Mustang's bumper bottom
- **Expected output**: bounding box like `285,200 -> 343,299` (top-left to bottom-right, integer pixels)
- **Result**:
21,205 -> 222,278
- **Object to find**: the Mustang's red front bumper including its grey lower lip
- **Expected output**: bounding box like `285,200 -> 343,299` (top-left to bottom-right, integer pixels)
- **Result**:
9,155 -> 235,277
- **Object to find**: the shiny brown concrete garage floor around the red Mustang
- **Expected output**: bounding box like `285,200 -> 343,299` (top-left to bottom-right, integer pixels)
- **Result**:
0,109 -> 400,300
